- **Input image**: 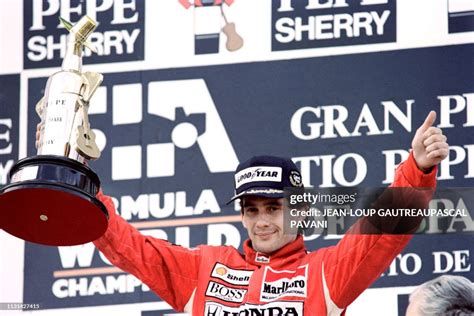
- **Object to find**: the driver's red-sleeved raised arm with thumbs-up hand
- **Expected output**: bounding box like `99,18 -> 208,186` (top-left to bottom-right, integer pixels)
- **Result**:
323,111 -> 448,310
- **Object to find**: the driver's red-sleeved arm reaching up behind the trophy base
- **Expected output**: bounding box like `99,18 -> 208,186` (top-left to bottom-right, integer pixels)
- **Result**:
94,192 -> 201,311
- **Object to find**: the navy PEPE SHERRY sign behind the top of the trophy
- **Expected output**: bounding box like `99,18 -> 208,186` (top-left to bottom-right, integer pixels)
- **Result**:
23,0 -> 145,69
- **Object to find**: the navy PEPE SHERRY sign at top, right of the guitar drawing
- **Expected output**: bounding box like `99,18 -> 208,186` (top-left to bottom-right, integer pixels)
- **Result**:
271,0 -> 397,51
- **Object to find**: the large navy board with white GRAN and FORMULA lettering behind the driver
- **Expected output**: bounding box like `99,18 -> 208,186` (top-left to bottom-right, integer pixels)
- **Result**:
19,45 -> 474,308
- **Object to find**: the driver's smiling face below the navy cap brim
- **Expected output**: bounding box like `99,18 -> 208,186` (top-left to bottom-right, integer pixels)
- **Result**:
242,196 -> 296,255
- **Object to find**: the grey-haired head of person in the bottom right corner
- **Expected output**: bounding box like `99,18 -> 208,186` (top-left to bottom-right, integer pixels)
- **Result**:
406,275 -> 474,316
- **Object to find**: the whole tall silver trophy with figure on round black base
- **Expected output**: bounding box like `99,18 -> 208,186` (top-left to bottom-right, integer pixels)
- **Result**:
0,16 -> 108,246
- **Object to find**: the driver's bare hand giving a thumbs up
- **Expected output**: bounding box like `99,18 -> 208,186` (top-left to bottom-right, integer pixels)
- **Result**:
411,111 -> 449,171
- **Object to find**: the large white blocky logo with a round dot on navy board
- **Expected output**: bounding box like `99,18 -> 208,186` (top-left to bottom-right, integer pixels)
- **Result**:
90,79 -> 238,180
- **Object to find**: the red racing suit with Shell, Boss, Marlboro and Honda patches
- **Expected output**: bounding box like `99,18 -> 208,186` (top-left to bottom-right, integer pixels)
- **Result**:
94,154 -> 436,316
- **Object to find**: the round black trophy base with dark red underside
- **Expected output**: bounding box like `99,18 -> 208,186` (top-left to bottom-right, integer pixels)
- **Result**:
0,156 -> 108,246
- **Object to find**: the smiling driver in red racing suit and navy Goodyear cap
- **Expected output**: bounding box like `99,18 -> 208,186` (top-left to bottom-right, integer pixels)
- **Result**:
94,112 -> 448,316
